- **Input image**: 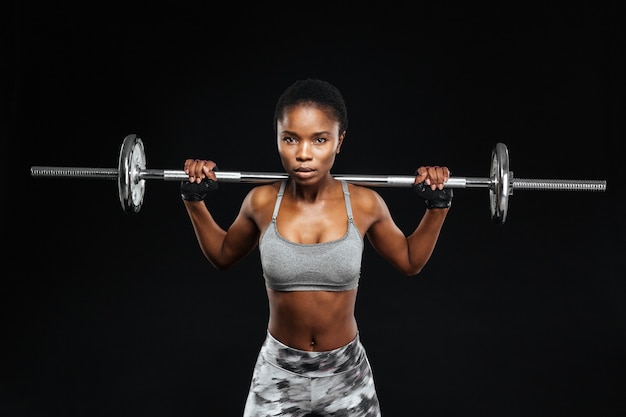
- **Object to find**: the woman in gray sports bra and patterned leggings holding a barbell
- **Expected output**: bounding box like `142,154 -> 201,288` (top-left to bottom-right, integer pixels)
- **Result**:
181,79 -> 452,417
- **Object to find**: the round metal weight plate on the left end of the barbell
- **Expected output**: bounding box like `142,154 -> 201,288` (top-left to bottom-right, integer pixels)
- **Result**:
117,135 -> 146,214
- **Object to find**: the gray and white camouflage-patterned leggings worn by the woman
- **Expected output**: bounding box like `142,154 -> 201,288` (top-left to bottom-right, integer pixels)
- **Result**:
244,332 -> 381,417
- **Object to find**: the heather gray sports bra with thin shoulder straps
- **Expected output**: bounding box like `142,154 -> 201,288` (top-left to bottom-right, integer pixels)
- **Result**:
259,180 -> 363,291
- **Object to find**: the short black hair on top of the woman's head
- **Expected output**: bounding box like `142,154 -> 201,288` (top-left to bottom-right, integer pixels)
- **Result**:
274,78 -> 348,134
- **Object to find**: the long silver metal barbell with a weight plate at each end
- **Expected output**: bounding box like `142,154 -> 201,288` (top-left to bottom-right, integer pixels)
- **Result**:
30,134 -> 606,224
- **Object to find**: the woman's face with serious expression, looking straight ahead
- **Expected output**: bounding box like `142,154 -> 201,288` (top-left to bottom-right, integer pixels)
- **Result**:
276,105 -> 345,182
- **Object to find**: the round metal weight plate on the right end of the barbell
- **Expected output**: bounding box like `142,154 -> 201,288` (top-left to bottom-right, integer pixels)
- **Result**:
489,142 -> 513,224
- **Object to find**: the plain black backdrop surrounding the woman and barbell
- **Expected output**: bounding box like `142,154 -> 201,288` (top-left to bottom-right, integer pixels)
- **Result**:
0,1 -> 626,417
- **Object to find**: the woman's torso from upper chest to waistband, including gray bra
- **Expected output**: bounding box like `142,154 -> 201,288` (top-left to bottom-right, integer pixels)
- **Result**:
259,183 -> 363,351
